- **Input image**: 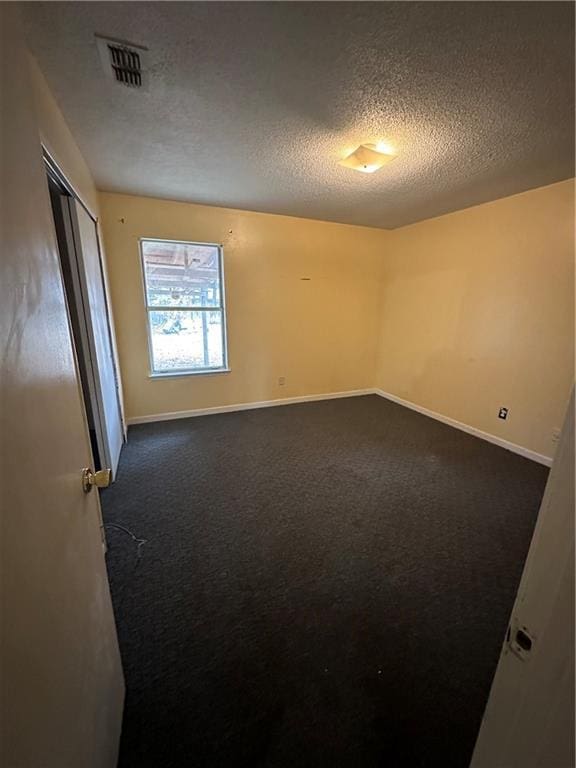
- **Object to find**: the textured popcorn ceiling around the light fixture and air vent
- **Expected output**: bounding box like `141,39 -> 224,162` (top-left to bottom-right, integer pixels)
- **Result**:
23,2 -> 574,228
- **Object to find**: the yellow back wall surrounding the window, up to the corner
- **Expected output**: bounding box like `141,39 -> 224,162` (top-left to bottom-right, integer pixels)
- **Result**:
100,193 -> 390,418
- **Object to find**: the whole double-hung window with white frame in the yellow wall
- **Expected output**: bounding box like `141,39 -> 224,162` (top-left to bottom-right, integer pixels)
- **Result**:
140,240 -> 227,376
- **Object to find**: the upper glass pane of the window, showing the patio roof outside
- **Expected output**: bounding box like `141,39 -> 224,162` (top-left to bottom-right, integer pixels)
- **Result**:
142,240 -> 220,307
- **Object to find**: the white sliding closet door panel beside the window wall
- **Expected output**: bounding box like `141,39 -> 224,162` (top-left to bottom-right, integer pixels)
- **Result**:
68,197 -> 124,477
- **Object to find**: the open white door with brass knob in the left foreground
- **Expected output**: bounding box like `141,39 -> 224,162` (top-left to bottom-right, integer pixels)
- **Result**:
0,3 -> 124,768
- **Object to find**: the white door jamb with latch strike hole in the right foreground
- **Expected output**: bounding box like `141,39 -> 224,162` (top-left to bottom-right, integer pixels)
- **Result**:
471,392 -> 575,768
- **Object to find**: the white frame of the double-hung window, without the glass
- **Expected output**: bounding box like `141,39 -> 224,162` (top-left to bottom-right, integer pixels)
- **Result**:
138,237 -> 230,379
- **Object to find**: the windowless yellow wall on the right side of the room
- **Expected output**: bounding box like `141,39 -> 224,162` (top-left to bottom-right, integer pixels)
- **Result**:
377,181 -> 574,456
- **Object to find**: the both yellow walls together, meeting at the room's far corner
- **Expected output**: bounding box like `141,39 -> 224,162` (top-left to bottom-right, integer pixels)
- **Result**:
100,181 -> 574,456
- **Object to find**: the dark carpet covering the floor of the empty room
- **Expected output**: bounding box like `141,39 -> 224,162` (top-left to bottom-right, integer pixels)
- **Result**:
103,396 -> 547,768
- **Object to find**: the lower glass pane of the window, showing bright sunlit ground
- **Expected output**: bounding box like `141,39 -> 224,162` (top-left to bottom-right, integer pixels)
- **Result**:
148,310 -> 224,373
